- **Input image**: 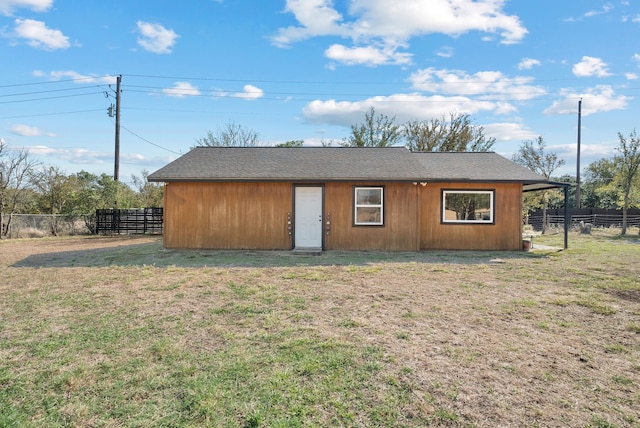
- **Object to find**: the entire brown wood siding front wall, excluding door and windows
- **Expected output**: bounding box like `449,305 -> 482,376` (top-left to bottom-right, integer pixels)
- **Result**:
164,182 -> 522,251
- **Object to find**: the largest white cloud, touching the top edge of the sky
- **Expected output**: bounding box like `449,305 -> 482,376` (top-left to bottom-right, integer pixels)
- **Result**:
271,0 -> 527,65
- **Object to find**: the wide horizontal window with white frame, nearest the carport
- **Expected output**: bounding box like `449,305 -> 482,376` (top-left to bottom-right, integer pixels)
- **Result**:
442,190 -> 495,224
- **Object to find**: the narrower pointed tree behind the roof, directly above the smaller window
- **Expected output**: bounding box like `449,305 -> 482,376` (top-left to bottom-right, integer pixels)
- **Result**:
343,107 -> 402,147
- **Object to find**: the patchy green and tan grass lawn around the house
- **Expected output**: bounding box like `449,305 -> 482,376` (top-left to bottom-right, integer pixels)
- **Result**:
0,229 -> 640,427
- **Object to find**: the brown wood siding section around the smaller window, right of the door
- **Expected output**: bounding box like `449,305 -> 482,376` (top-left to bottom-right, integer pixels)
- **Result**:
325,183 -> 420,251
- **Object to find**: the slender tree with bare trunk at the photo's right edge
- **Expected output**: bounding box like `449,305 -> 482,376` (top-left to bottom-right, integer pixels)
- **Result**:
613,129 -> 640,235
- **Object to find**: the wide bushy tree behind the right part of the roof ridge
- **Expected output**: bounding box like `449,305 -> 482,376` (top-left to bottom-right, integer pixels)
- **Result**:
402,113 -> 496,152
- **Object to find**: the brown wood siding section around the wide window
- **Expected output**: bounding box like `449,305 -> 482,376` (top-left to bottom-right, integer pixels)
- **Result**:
420,183 -> 522,250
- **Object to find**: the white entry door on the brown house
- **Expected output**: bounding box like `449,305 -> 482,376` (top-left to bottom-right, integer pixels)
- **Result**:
294,186 -> 322,248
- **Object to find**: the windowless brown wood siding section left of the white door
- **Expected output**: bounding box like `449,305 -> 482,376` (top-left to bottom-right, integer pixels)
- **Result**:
164,183 -> 292,250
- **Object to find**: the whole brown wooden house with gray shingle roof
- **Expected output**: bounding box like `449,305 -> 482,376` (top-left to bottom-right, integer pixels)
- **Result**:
148,147 -> 548,251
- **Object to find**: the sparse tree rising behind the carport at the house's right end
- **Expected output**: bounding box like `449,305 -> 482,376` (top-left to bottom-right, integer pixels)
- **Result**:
512,137 -> 564,233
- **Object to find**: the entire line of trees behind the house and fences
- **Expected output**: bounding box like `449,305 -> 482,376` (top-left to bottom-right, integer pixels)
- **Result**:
0,107 -> 640,234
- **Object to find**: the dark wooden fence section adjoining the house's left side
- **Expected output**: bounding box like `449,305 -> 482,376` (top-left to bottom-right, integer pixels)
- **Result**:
96,208 -> 163,234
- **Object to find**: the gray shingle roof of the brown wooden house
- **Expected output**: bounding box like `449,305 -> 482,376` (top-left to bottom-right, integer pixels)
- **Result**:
148,147 -> 546,182
